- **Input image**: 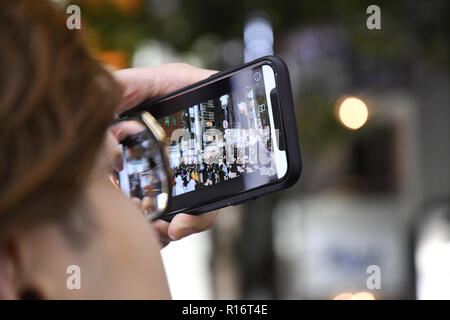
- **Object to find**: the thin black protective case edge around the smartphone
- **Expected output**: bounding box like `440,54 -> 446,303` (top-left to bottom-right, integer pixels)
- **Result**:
120,56 -> 302,221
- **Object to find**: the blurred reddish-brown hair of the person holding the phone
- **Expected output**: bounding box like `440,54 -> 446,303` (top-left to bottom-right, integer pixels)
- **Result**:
0,0 -> 121,247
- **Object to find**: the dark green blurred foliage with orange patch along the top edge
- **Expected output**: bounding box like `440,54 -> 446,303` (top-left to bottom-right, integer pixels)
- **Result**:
73,0 -> 450,68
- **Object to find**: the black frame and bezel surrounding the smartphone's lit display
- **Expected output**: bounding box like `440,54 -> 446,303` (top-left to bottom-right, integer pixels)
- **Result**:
120,56 -> 302,220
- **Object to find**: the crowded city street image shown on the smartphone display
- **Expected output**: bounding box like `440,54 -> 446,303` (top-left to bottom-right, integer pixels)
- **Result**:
160,71 -> 276,196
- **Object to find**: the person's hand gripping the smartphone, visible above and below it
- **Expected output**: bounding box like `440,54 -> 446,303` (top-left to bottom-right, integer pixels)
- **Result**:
110,63 -> 218,246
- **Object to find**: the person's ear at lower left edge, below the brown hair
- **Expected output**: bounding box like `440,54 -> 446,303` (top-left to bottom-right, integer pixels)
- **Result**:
0,244 -> 19,300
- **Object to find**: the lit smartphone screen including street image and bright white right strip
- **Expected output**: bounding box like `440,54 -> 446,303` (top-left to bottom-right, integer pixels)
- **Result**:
158,64 -> 287,198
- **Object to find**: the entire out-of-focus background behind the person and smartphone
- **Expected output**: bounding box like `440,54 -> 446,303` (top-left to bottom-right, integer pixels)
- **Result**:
55,0 -> 450,299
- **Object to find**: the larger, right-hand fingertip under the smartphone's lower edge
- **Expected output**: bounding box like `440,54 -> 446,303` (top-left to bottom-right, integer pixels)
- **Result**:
168,210 -> 219,240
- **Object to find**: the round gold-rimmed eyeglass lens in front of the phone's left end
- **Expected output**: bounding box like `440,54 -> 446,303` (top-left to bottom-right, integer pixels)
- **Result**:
110,111 -> 173,221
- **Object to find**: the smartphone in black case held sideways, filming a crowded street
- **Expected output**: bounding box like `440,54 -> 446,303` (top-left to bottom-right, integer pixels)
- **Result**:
121,56 -> 302,219
